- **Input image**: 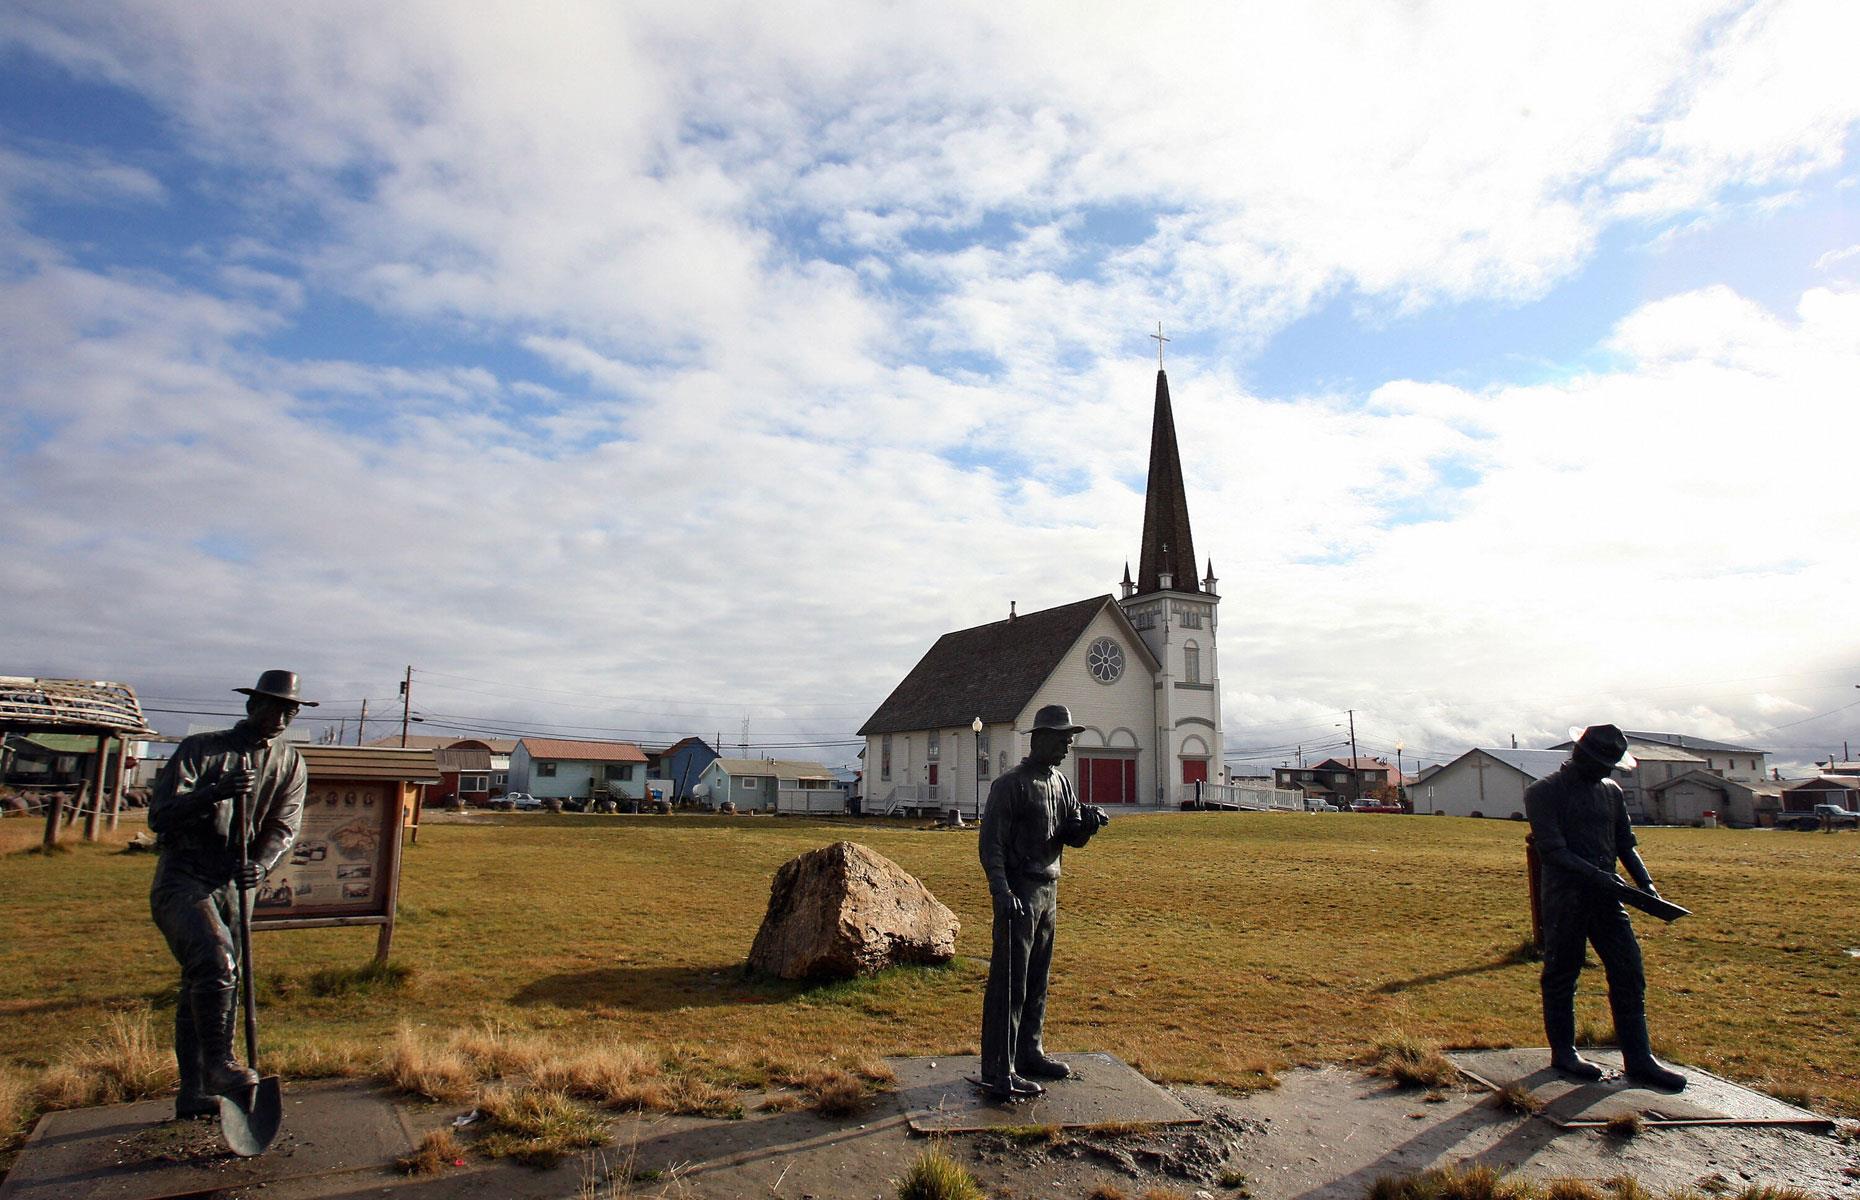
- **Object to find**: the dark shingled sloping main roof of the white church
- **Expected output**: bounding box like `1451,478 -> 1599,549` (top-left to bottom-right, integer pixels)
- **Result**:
859,595 -> 1149,737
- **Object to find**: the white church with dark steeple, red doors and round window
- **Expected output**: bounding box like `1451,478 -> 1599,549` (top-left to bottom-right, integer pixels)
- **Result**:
859,365 -> 1222,813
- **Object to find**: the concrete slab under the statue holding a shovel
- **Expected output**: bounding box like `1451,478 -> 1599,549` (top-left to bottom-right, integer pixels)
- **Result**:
0,1079 -> 413,1200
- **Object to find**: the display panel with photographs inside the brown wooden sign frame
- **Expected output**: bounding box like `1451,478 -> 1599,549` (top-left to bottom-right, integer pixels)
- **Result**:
251,776 -> 400,927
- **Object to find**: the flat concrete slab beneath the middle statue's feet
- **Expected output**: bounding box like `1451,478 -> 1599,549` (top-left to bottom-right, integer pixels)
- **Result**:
887,1053 -> 1202,1133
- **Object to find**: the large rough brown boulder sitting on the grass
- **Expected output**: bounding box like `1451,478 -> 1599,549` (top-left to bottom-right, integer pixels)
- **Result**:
750,841 -> 962,979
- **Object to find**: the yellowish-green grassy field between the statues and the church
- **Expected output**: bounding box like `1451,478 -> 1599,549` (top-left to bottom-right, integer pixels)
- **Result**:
0,813 -> 1860,1116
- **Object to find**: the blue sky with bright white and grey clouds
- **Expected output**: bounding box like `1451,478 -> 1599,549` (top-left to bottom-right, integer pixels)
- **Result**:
0,0 -> 1860,767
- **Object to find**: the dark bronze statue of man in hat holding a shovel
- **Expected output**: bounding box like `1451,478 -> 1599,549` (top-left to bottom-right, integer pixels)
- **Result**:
149,672 -> 316,1153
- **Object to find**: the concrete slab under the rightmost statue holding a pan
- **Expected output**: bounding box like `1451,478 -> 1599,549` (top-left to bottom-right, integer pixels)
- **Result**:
1447,1047 -> 1832,1129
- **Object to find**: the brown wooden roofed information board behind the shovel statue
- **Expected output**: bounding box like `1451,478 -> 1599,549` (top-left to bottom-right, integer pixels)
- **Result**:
251,746 -> 439,960
